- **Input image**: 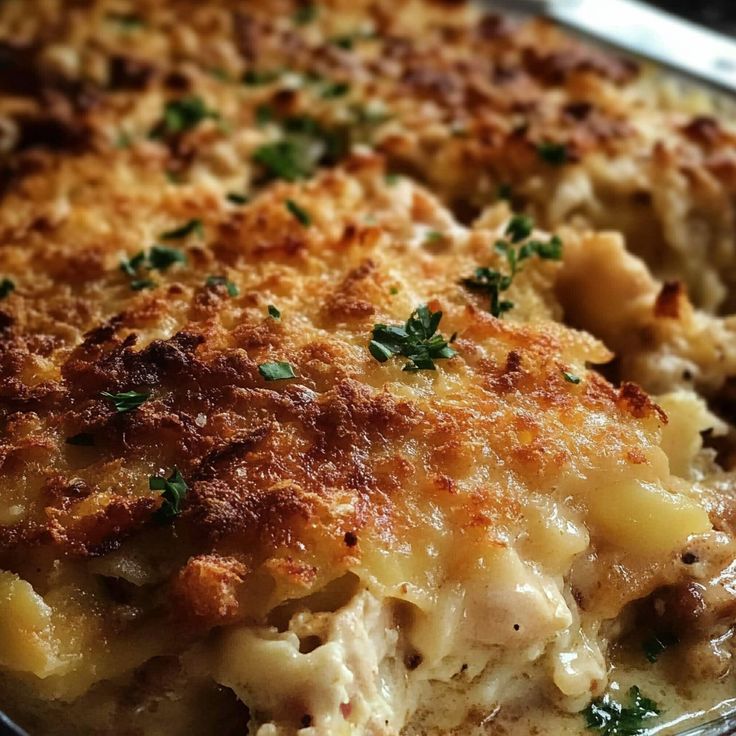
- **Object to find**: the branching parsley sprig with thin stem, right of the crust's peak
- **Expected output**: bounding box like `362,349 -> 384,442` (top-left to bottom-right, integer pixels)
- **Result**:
461,215 -> 562,317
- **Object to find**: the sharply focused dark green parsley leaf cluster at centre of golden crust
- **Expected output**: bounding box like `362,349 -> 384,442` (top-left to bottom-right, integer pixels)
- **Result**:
368,305 -> 457,371
